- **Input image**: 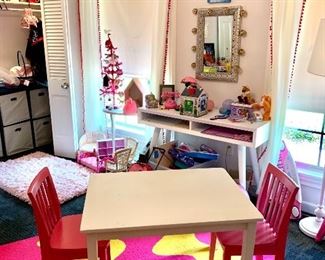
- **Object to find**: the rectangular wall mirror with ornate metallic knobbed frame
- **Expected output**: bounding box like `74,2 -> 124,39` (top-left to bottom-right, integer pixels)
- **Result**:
192,6 -> 246,82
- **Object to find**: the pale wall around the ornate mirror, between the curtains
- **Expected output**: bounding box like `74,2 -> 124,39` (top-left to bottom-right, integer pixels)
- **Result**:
176,0 -> 270,106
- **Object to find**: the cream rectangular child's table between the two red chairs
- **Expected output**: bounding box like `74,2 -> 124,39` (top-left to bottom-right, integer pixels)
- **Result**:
81,168 -> 263,260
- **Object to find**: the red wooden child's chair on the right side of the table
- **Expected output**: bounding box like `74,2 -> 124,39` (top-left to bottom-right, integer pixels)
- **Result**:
209,164 -> 298,260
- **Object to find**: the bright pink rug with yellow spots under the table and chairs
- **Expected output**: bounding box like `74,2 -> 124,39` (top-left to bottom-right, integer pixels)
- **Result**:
0,233 -> 274,260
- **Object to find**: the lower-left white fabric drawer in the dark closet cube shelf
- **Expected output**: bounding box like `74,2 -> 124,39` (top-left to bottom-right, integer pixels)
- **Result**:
3,121 -> 34,155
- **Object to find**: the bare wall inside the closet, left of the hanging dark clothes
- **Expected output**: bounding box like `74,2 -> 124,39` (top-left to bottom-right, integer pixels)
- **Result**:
0,11 -> 29,69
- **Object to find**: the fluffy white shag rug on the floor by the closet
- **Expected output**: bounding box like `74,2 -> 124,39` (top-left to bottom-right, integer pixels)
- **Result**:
0,152 -> 92,203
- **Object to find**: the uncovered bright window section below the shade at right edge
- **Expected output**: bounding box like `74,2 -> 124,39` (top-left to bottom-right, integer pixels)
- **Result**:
283,109 -> 325,176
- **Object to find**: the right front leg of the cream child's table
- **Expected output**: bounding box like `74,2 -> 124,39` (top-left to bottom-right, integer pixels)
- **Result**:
241,223 -> 256,260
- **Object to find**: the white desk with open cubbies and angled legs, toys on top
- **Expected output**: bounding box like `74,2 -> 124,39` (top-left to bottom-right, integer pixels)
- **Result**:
138,108 -> 270,188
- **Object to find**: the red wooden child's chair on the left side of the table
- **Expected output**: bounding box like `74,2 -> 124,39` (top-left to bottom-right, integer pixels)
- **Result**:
28,167 -> 110,260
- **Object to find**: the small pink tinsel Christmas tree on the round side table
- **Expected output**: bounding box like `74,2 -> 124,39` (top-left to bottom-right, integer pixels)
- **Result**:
100,33 -> 123,109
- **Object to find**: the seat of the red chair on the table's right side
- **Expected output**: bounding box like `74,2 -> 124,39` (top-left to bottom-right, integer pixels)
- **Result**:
217,221 -> 276,255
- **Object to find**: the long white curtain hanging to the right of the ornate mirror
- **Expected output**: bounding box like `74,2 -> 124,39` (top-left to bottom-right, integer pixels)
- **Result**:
261,0 -> 303,187
